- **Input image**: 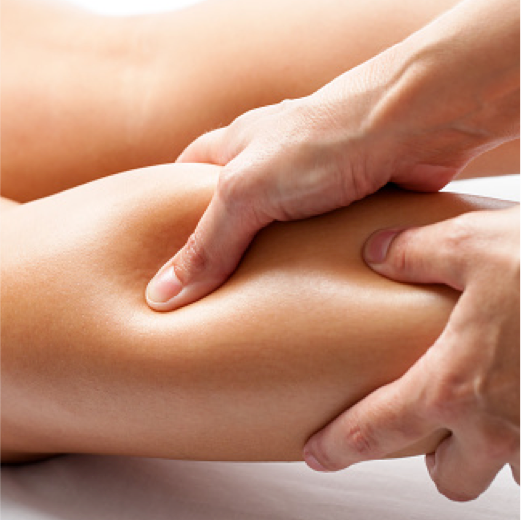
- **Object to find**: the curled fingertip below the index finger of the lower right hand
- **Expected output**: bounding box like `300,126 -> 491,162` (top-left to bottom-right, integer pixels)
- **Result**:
426,434 -> 504,502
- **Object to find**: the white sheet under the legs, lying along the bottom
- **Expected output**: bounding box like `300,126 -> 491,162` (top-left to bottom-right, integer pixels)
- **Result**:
0,0 -> 521,520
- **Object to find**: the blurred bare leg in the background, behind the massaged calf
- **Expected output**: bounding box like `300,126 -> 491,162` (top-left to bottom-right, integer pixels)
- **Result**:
0,0 -> 520,201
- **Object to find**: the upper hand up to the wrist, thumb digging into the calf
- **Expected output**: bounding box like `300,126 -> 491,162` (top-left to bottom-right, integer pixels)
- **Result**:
143,41 -> 481,311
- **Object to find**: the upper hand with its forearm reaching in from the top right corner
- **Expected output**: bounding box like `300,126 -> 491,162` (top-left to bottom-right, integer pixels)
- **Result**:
151,0 -> 521,311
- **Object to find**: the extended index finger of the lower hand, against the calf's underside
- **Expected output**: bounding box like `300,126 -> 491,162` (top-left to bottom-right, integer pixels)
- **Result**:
304,362 -> 439,471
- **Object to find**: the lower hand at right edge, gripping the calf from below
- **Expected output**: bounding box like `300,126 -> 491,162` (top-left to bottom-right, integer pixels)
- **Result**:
304,207 -> 521,501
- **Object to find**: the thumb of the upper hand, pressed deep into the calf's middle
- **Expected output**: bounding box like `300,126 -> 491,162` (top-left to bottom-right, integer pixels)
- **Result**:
146,171 -> 267,311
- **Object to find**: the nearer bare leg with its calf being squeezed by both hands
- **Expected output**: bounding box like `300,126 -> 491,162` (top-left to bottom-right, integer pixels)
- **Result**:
0,165 -> 508,461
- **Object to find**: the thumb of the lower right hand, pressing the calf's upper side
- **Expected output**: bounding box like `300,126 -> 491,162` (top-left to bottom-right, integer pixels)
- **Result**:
363,215 -> 473,290
